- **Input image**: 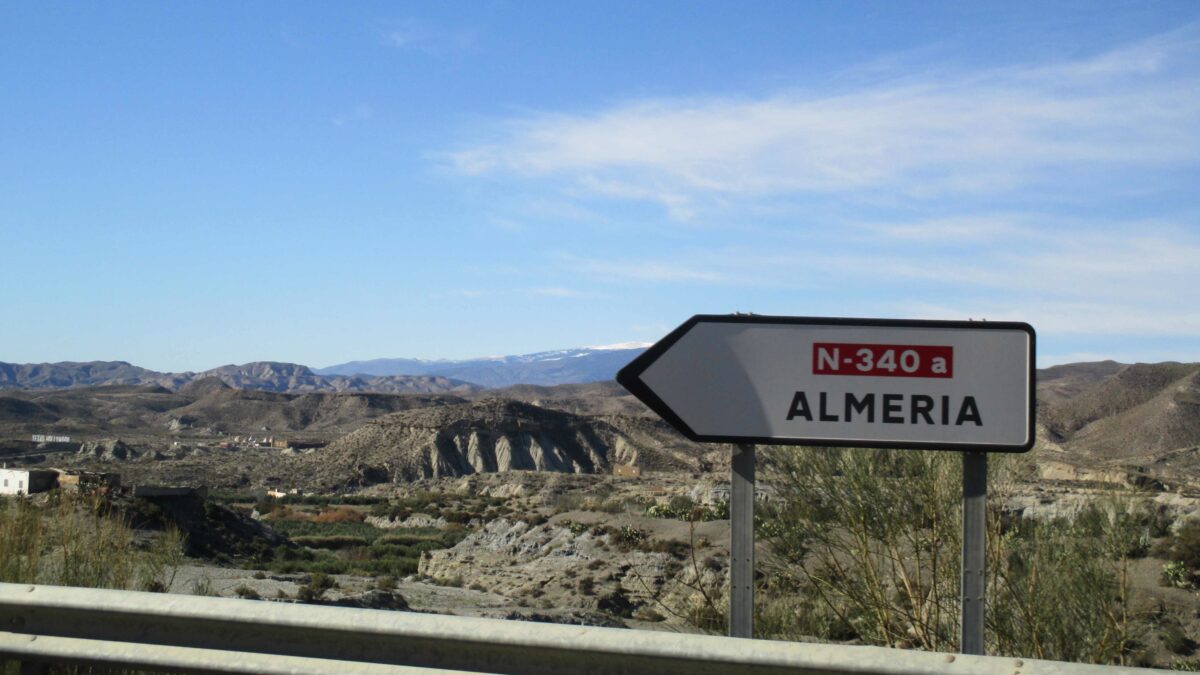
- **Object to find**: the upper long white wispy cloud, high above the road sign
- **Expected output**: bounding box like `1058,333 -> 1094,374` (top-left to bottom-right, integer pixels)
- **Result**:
449,26 -> 1200,219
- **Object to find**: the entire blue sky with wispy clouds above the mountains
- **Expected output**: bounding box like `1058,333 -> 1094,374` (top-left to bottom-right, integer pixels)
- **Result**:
0,1 -> 1200,370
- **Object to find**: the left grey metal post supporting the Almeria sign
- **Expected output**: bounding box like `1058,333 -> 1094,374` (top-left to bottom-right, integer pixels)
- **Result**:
730,444 -> 755,638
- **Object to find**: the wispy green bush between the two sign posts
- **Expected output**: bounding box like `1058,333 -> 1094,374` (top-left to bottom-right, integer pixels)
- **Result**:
763,448 -> 961,650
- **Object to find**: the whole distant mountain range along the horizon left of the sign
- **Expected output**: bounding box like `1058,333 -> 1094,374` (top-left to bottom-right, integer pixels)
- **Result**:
0,342 -> 648,394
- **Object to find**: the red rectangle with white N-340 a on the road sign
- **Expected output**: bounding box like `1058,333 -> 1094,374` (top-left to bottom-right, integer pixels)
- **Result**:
812,342 -> 954,378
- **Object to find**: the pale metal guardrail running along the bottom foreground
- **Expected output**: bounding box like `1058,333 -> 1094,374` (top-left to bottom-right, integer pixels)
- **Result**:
0,584 -> 1151,675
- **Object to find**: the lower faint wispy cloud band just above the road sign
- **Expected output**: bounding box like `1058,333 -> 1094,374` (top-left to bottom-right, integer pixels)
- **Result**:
549,210 -> 1200,338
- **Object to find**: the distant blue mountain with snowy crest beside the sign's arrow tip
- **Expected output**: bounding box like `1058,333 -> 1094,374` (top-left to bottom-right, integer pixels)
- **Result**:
314,342 -> 649,387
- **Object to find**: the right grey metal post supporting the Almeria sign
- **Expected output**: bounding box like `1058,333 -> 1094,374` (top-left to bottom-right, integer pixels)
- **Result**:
959,452 -> 988,656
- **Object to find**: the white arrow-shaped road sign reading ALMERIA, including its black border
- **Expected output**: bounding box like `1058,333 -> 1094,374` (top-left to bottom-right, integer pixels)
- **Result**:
617,315 -> 1036,452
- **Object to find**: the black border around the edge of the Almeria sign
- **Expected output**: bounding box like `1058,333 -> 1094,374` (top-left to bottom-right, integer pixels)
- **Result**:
617,315 -> 1037,453
